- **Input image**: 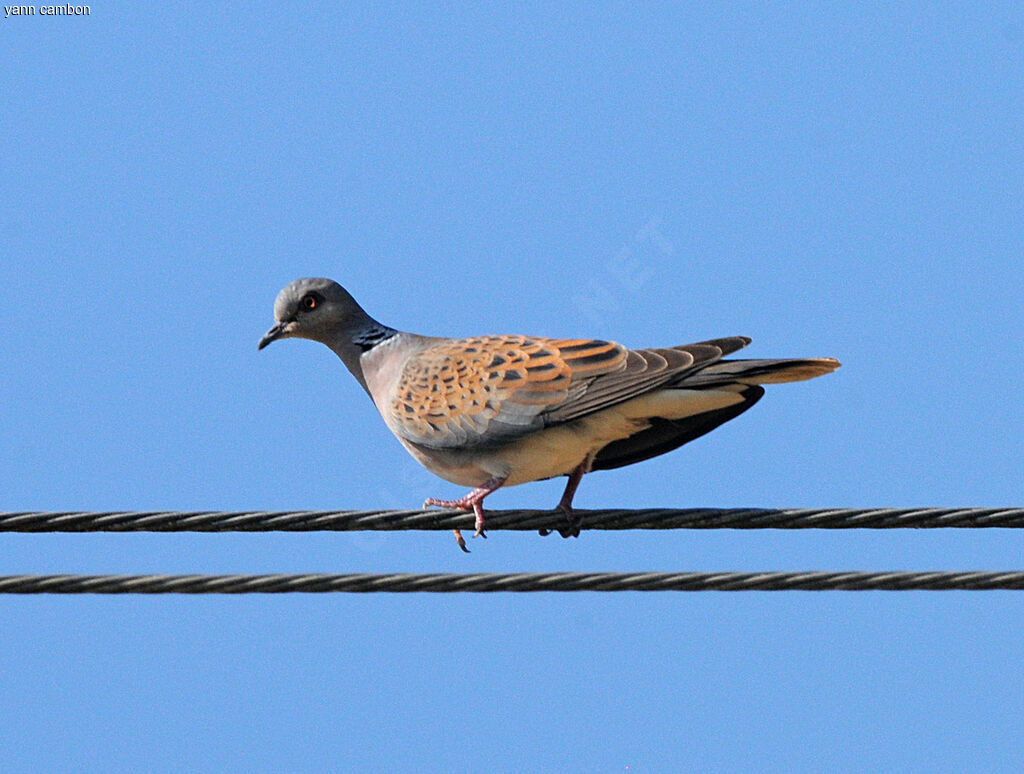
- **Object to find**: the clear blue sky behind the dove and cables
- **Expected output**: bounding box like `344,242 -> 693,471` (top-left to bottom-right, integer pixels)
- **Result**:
0,2 -> 1024,772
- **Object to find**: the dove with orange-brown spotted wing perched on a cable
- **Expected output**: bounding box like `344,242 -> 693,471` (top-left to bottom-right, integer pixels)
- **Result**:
258,277 -> 840,552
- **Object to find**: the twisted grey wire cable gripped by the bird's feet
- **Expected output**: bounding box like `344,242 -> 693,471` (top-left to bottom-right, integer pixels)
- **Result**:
0,508 -> 1024,532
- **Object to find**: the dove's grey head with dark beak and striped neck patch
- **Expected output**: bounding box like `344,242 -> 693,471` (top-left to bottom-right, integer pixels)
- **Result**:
259,277 -> 397,386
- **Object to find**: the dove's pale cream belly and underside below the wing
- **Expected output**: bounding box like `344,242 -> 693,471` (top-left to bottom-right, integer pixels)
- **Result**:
402,389 -> 742,486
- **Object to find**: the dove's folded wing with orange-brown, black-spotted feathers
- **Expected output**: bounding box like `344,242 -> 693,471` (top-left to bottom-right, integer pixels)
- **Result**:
385,336 -> 749,448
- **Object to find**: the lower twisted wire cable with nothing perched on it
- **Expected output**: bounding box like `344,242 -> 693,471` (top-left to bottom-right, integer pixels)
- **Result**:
0,571 -> 1024,594
